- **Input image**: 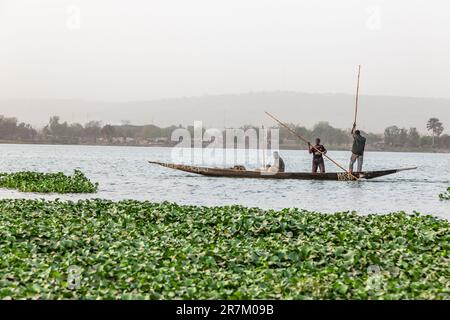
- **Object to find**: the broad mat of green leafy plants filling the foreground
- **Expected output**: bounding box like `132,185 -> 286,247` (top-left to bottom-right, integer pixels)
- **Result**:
0,200 -> 450,299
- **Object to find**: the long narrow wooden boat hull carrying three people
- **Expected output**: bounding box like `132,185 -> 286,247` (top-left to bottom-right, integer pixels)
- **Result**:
149,161 -> 416,181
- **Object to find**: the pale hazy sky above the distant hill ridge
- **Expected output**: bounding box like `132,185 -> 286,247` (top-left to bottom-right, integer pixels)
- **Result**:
0,0 -> 450,101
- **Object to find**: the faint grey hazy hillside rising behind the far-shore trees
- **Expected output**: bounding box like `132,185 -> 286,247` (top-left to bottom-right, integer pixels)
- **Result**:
0,92 -> 450,133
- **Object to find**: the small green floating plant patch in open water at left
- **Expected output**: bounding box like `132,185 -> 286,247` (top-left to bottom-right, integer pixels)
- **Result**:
0,170 -> 98,193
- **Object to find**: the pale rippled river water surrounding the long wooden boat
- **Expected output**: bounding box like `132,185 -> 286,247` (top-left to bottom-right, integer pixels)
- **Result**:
0,144 -> 450,219
